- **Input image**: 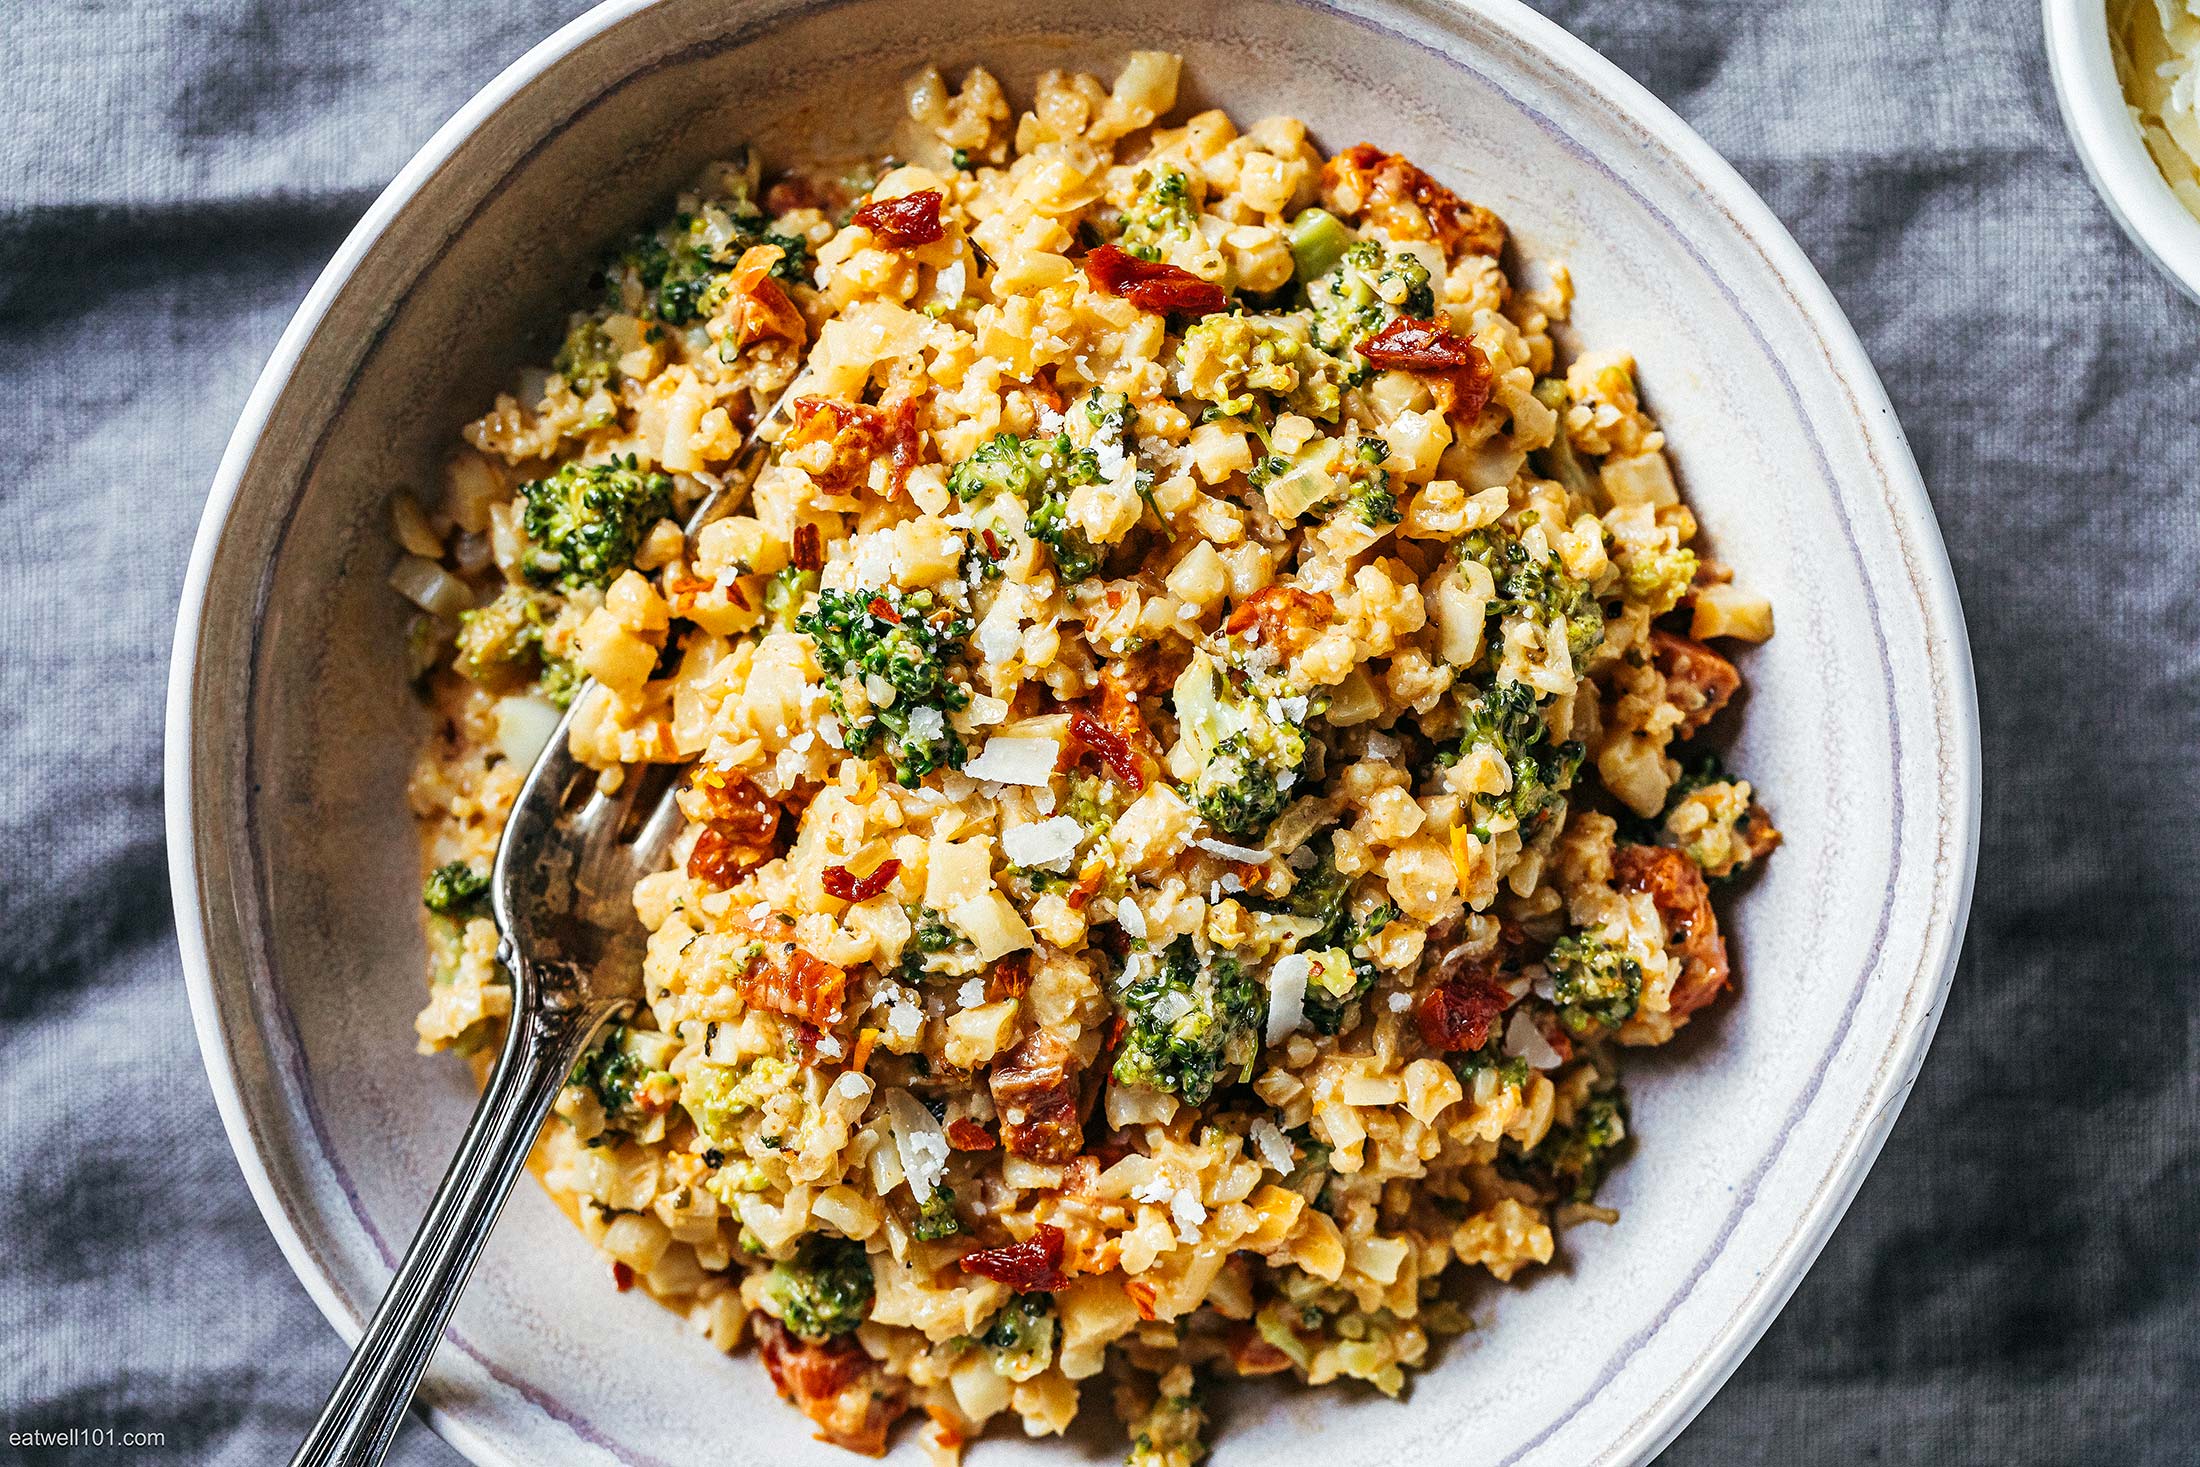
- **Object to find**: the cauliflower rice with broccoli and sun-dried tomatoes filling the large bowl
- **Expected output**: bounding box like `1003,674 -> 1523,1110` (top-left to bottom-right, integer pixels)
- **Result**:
394,53 -> 1778,1467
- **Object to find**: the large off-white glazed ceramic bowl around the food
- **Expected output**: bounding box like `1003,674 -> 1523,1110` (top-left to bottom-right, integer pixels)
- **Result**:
167,0 -> 1978,1467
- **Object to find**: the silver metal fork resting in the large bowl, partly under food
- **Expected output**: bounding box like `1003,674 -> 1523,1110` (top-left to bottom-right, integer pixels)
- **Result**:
290,378 -> 807,1467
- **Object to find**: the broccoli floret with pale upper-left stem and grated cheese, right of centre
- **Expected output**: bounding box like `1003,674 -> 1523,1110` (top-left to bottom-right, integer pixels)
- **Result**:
1170,651 -> 1311,838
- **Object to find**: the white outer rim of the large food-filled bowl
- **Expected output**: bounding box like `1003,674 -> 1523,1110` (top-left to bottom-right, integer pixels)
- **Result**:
163,0 -> 1988,1467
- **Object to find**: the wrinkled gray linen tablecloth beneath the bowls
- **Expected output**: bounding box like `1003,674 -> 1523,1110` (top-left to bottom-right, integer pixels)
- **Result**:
0,0 -> 2200,1467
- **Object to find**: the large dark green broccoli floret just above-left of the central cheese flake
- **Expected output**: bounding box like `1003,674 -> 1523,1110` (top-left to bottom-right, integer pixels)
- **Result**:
794,592 -> 972,787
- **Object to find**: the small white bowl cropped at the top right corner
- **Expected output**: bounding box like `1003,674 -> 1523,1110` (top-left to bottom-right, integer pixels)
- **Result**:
2042,0 -> 2200,301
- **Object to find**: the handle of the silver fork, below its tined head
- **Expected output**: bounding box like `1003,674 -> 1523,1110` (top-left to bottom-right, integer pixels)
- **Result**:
290,994 -> 616,1467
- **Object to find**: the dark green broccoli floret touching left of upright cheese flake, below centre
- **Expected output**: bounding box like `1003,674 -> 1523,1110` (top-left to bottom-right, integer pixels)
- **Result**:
1115,937 -> 1267,1106
